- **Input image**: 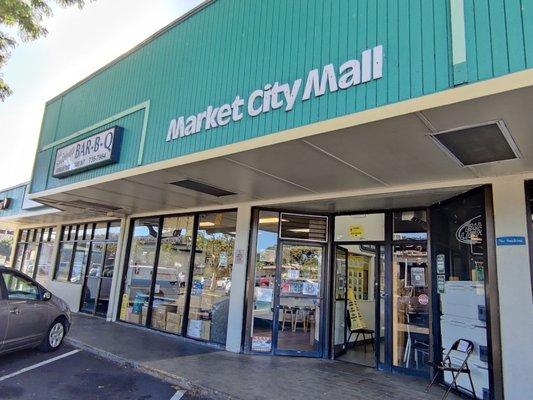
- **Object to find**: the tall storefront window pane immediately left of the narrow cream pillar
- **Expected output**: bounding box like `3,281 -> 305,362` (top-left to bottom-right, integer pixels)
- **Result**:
187,212 -> 237,344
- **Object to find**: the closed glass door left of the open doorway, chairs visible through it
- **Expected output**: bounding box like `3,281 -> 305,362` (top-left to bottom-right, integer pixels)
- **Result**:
274,243 -> 324,356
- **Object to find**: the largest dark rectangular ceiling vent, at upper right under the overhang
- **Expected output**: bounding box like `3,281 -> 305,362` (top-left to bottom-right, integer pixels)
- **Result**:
430,121 -> 520,166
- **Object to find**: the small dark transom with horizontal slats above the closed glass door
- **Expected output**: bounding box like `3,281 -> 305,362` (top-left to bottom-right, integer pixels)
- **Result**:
279,213 -> 328,242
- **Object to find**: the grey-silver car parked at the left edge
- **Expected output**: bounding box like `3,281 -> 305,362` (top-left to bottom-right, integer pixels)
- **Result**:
0,266 -> 71,354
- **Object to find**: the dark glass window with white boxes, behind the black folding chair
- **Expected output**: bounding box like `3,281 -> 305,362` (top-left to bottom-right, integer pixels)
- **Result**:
431,191 -> 490,394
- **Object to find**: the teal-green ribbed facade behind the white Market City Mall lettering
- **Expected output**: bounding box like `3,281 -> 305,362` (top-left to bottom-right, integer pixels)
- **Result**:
31,0 -> 533,193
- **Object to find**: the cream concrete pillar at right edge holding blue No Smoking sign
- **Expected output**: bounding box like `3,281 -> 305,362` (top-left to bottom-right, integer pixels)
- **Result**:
493,176 -> 533,400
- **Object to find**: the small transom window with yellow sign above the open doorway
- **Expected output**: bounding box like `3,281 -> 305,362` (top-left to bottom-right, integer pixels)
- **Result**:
335,214 -> 385,242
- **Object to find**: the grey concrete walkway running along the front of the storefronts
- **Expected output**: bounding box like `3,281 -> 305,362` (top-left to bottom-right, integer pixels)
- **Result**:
67,314 -> 458,400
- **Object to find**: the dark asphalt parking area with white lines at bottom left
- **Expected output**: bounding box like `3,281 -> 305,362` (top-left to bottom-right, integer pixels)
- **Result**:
0,345 -> 203,400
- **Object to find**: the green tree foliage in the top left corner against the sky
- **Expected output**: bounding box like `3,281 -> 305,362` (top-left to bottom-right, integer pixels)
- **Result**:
0,0 -> 89,101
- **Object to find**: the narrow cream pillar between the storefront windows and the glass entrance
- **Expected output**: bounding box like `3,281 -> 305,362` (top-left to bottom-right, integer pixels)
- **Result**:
226,205 -> 252,353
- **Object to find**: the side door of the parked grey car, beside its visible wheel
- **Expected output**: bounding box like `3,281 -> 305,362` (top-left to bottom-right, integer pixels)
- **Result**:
2,271 -> 49,351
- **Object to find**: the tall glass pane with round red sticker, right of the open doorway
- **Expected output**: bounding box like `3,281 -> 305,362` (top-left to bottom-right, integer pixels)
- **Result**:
392,243 -> 430,371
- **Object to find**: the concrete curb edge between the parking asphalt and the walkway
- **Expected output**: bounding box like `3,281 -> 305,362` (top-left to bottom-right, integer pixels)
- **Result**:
65,337 -> 235,400
